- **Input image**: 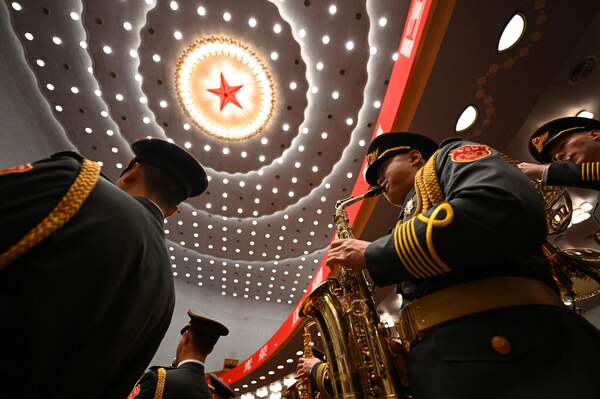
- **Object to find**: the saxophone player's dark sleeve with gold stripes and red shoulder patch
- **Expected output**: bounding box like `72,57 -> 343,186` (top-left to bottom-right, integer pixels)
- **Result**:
365,141 -> 546,286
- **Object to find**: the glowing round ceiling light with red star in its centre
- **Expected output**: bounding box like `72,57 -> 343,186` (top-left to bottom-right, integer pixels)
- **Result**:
175,36 -> 275,140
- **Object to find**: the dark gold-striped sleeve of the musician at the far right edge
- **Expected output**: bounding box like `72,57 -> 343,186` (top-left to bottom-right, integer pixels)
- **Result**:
546,162 -> 600,191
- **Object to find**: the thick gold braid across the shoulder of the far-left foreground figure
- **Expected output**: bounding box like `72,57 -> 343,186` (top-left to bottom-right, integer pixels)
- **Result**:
0,159 -> 100,271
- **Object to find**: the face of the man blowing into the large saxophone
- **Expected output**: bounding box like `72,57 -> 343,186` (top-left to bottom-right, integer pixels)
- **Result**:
377,150 -> 424,206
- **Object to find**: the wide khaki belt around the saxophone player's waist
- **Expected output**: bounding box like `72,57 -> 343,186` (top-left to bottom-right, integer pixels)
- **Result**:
396,277 -> 564,352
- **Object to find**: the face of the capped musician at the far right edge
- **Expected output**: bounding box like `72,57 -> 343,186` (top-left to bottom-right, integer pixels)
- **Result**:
549,130 -> 600,164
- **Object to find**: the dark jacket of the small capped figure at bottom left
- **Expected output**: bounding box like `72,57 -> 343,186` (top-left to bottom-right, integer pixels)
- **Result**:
129,363 -> 211,399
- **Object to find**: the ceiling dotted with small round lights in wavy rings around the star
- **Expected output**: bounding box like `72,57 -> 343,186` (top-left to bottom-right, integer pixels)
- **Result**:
7,0 -> 408,304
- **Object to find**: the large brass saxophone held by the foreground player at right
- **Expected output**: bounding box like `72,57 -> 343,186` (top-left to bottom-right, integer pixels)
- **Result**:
299,187 -> 405,399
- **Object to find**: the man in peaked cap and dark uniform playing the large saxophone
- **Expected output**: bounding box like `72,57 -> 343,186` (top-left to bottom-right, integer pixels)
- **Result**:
327,132 -> 600,399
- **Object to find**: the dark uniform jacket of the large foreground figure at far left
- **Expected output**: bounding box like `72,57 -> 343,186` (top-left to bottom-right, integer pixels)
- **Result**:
0,153 -> 175,399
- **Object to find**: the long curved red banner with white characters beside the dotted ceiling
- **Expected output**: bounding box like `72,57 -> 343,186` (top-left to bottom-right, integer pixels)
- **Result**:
221,0 -> 433,384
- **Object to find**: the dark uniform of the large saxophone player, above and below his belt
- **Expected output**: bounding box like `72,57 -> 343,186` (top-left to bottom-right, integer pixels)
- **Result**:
365,141 -> 600,399
